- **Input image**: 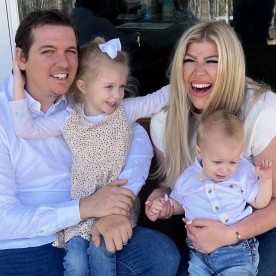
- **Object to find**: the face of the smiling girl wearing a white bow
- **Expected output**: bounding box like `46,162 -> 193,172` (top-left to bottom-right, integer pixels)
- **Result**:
77,62 -> 128,116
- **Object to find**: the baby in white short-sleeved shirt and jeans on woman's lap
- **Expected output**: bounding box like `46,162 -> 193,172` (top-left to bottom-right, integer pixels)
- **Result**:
149,110 -> 272,275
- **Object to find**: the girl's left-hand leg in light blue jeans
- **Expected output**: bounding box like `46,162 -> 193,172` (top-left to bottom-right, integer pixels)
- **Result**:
63,236 -> 89,276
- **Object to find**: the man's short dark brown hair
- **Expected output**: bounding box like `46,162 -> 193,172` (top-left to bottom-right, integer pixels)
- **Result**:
15,9 -> 79,60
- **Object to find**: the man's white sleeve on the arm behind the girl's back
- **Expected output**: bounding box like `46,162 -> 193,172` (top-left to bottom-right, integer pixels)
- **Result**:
118,123 -> 153,195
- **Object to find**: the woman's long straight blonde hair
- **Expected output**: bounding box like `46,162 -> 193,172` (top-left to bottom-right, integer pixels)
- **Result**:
161,22 -> 268,187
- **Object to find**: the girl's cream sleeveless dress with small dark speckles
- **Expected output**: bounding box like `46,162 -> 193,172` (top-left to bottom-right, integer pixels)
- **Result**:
53,104 -> 140,247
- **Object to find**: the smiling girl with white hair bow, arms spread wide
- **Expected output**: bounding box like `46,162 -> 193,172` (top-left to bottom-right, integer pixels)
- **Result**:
10,38 -> 168,275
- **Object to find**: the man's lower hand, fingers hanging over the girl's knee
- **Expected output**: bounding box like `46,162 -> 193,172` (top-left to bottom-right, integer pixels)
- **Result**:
92,215 -> 132,253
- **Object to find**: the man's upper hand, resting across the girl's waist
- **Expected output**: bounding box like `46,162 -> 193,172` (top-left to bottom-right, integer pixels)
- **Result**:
80,180 -> 135,219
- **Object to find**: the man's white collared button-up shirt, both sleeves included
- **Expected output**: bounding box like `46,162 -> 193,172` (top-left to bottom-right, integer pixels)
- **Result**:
0,75 -> 153,249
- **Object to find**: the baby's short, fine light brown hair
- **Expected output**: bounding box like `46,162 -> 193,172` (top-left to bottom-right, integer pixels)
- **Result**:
197,110 -> 244,145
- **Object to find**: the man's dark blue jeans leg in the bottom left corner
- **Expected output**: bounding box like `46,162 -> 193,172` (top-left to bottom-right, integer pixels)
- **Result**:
0,244 -> 65,276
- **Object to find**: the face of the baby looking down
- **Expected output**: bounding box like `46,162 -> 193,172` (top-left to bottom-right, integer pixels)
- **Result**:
197,135 -> 243,182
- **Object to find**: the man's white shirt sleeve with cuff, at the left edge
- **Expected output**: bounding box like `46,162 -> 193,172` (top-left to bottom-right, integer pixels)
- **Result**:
0,135 -> 80,240
